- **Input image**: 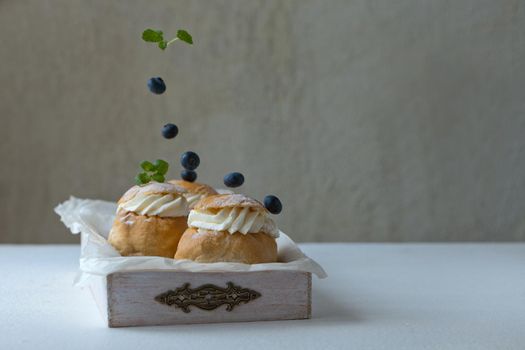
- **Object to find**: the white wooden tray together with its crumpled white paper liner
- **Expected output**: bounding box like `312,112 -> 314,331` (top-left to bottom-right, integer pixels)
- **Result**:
55,197 -> 326,327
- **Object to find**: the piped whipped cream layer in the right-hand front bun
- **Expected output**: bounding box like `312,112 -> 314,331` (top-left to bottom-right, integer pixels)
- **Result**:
188,207 -> 279,238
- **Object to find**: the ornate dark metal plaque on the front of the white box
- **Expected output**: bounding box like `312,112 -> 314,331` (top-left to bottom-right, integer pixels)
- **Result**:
155,282 -> 261,313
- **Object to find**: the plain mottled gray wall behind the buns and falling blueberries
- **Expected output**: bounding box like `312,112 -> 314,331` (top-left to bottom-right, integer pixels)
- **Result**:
0,0 -> 525,243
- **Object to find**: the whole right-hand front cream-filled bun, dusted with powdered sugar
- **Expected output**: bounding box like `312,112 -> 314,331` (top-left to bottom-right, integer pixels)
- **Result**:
175,194 -> 279,264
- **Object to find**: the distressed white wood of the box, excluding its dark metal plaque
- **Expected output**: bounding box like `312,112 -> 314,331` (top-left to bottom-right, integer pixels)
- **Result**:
91,271 -> 312,327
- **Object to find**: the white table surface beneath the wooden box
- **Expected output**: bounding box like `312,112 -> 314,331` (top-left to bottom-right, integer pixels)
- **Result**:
0,243 -> 525,350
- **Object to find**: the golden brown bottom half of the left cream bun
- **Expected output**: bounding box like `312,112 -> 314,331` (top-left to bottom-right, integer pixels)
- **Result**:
108,210 -> 187,258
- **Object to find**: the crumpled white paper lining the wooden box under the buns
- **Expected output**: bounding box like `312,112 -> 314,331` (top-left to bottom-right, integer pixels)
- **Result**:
55,197 -> 327,286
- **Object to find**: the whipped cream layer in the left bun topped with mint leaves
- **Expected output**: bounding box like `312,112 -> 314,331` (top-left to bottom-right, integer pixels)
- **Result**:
119,193 -> 189,217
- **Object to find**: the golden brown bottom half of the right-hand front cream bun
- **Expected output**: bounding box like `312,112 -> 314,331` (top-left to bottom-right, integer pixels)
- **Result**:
175,227 -> 277,264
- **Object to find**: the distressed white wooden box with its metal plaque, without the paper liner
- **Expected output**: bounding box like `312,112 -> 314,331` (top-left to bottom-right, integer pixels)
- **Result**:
90,270 -> 312,327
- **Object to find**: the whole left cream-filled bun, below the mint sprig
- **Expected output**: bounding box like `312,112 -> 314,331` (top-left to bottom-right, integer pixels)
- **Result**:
108,182 -> 189,258
